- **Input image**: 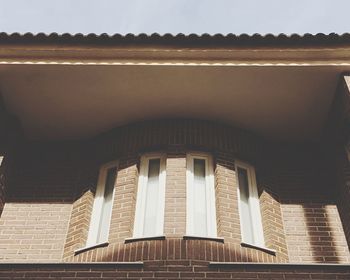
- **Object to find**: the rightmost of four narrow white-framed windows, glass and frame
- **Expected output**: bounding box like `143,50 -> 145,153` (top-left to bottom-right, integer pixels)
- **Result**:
235,161 -> 264,246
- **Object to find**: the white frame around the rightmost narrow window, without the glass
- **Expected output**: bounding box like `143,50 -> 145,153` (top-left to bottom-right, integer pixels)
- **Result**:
235,160 -> 265,247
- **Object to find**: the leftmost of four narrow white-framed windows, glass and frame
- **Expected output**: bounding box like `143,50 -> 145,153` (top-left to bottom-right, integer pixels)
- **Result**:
86,162 -> 117,246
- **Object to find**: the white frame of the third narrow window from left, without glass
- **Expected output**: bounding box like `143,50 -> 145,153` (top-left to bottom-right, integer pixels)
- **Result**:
186,152 -> 217,238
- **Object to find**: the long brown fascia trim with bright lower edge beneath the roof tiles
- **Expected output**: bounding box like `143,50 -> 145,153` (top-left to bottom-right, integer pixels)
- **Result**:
4,44 -> 350,67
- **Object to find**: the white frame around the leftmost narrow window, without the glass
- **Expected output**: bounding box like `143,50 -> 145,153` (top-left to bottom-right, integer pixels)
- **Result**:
86,161 -> 118,247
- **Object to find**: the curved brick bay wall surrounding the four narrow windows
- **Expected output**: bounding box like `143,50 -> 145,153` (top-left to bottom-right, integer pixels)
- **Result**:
64,120 -> 288,262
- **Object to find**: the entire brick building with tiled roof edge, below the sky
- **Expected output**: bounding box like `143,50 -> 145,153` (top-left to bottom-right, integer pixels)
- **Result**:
0,34 -> 350,279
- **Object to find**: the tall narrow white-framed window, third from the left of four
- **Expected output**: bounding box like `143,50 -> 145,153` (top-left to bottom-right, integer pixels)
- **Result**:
186,154 -> 217,237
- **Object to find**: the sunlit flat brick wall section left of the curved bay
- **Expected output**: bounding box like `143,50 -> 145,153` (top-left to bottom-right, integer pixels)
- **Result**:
0,203 -> 71,262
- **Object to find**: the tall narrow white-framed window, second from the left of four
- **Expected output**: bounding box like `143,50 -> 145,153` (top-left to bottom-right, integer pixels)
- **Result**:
134,154 -> 165,238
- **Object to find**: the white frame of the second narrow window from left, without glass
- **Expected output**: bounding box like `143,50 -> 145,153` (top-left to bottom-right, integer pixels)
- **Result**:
133,153 -> 166,238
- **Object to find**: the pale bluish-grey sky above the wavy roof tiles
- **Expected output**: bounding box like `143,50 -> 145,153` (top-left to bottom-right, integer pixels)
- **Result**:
0,0 -> 350,34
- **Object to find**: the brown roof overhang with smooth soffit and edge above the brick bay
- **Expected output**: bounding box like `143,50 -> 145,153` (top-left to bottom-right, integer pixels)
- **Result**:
0,35 -> 350,141
